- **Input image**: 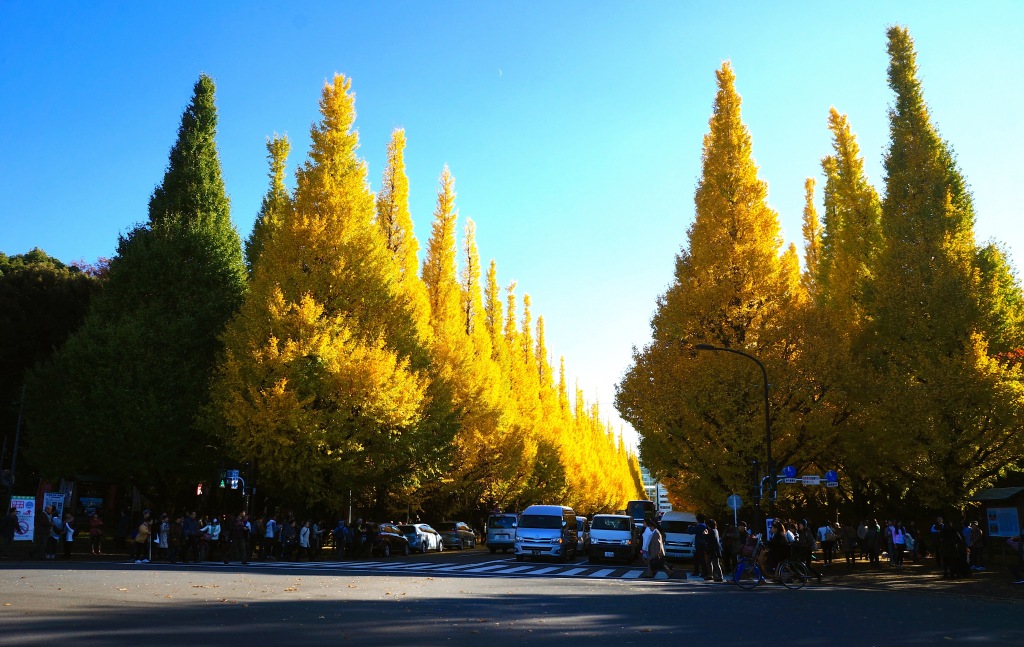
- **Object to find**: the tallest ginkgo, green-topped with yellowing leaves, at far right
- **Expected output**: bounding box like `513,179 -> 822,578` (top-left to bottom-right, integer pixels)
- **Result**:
865,27 -> 1024,507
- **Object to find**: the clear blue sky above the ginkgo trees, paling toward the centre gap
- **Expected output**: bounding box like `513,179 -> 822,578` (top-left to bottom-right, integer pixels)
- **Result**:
0,0 -> 1024,450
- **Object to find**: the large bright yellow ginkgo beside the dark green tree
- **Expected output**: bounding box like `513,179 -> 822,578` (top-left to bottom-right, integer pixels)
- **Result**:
210,75 -> 452,512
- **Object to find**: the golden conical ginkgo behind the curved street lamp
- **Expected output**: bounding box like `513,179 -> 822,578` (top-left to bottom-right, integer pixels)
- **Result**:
615,63 -> 800,513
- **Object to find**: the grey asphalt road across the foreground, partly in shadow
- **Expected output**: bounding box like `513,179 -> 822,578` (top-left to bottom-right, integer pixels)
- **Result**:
0,551 -> 1024,647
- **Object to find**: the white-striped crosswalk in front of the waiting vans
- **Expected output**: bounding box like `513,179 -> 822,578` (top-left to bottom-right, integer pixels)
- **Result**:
186,559 -> 671,579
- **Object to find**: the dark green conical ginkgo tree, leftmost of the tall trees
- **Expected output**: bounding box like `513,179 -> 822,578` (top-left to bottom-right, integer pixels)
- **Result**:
27,76 -> 245,494
